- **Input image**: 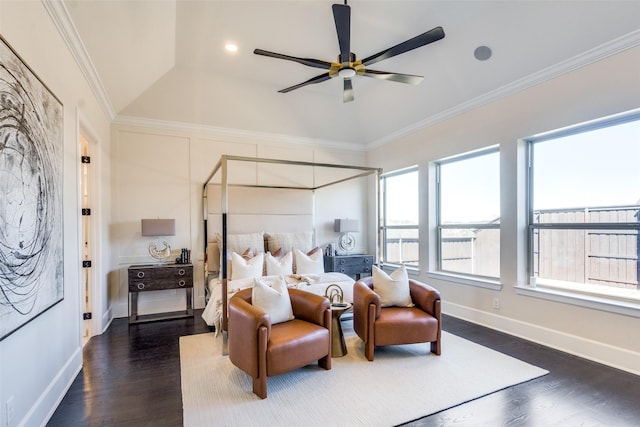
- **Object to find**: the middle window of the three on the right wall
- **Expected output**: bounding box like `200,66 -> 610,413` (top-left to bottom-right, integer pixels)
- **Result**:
436,148 -> 500,278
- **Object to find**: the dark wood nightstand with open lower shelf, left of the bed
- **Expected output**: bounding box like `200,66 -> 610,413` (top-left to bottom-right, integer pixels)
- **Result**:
128,264 -> 193,323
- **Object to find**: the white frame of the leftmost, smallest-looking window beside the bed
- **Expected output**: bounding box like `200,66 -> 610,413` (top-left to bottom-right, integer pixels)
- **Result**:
379,165 -> 420,273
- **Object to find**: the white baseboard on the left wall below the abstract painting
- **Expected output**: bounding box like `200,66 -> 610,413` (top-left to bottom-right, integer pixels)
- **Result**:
18,345 -> 82,426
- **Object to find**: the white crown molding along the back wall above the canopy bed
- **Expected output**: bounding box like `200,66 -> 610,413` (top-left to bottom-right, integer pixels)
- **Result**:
112,116 -> 366,151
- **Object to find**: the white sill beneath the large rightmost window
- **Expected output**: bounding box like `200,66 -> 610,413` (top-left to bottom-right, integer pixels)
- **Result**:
515,282 -> 640,317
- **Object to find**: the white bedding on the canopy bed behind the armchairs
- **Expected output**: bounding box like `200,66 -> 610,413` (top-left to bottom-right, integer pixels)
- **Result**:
202,273 -> 355,334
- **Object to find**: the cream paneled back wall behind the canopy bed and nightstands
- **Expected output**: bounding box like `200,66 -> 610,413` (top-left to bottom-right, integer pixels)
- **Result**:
109,119 -> 368,317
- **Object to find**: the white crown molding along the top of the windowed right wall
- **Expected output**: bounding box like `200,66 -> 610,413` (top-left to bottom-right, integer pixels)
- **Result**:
366,30 -> 640,151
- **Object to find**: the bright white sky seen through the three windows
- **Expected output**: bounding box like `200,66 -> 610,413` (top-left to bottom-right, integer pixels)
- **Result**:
387,115 -> 640,223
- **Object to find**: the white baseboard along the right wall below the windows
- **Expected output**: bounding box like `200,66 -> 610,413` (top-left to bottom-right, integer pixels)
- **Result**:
442,302 -> 640,375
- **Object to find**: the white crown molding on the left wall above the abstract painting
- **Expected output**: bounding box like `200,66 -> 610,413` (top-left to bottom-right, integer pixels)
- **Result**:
42,0 -> 116,120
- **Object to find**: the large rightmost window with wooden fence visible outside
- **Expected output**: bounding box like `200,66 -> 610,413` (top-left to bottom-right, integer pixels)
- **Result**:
528,114 -> 640,299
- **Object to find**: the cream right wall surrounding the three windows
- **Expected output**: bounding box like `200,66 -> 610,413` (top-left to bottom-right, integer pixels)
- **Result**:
368,42 -> 640,373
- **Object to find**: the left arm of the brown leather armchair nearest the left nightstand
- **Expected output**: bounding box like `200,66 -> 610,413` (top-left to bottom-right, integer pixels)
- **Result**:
229,289 -> 271,377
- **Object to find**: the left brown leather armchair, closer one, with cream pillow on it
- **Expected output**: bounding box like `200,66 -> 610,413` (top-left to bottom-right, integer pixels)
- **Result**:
228,288 -> 331,399
